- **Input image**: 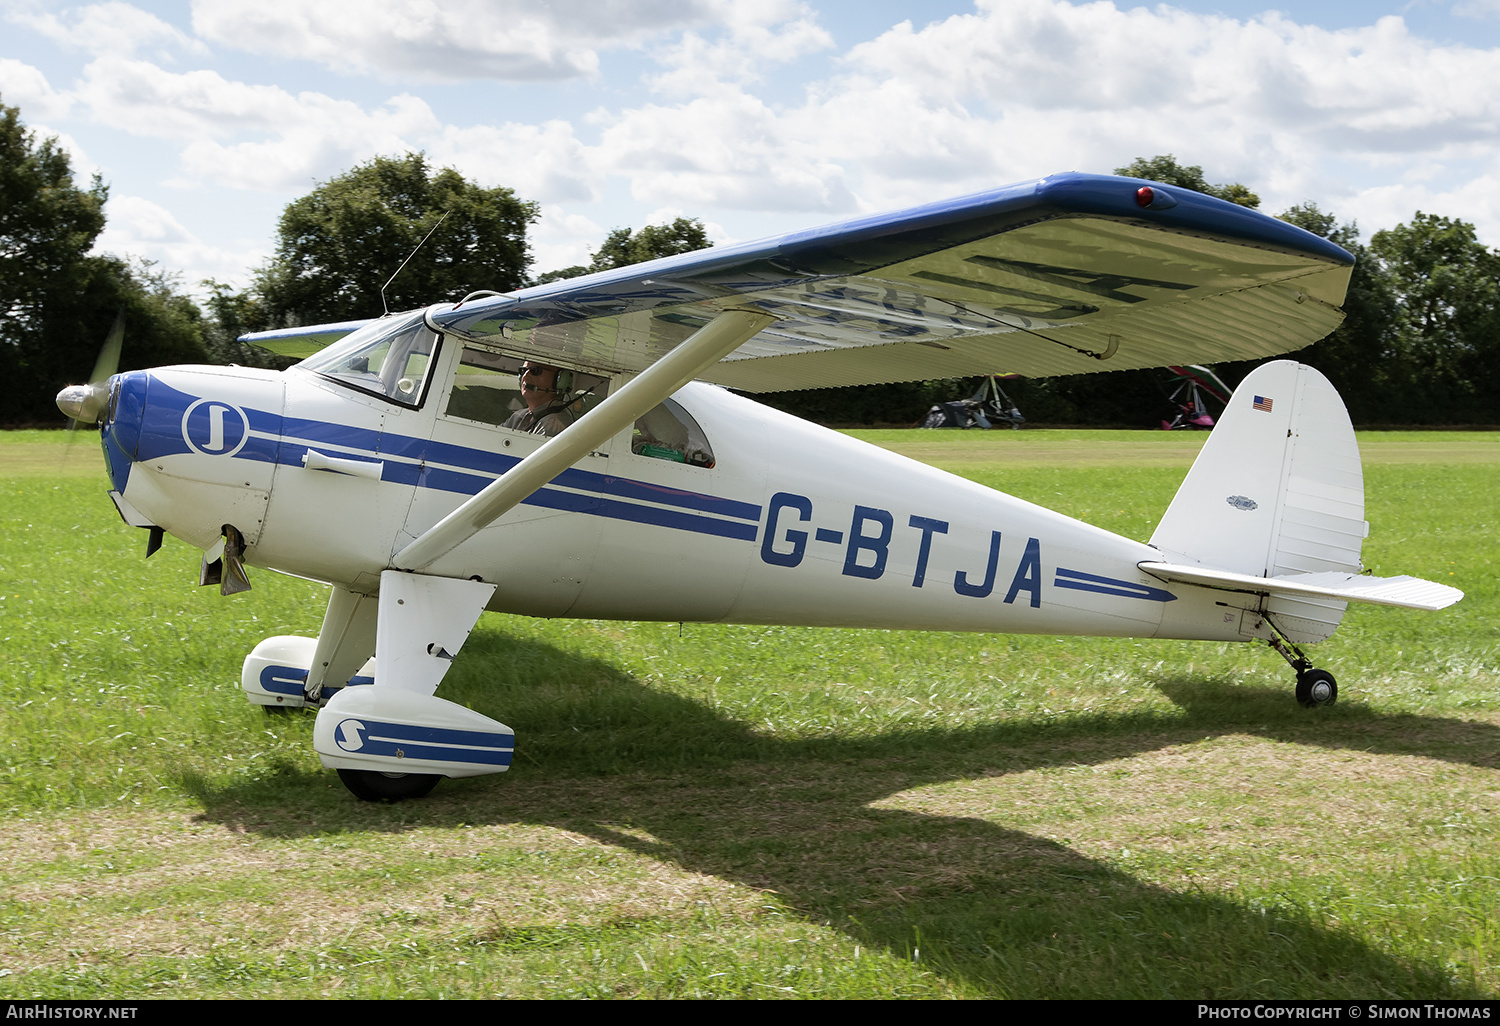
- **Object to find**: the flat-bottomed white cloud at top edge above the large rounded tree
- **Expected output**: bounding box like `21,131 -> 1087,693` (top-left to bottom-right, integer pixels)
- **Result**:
192,0 -> 723,81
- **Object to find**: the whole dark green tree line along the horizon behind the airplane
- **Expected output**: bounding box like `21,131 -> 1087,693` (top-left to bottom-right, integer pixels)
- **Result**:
0,104 -> 1500,426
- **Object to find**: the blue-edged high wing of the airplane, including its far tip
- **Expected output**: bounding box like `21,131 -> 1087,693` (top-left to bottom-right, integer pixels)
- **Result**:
246,174 -> 1353,392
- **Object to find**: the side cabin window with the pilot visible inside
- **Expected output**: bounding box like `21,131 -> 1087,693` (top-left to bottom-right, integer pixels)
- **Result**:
443,342 -> 609,435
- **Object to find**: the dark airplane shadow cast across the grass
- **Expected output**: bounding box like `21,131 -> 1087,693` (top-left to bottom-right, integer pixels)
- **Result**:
201,632 -> 1500,998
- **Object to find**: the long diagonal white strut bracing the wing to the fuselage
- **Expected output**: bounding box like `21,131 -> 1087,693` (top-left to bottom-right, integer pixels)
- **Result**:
392,309 -> 776,570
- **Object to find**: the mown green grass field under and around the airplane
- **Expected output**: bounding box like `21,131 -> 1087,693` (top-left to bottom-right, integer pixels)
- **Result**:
0,431 -> 1500,999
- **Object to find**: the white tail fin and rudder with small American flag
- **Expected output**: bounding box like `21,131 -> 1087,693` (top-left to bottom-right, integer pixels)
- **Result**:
1151,360 -> 1368,641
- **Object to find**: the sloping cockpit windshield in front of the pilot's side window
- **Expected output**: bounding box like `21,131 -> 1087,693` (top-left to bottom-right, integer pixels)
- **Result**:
297,311 -> 438,407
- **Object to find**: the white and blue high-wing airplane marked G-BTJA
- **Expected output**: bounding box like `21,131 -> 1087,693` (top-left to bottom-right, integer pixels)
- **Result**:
59,174 -> 1461,800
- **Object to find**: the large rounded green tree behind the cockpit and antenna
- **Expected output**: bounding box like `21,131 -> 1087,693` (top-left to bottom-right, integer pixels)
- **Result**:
253,153 -> 537,330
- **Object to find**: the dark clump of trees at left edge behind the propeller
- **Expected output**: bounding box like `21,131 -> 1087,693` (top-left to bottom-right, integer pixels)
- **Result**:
0,105 -> 206,425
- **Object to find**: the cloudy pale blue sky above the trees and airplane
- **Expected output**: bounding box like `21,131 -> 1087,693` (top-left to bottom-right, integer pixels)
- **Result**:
0,0 -> 1500,294
